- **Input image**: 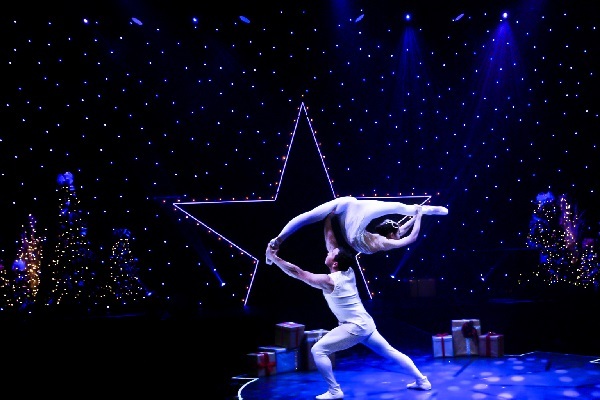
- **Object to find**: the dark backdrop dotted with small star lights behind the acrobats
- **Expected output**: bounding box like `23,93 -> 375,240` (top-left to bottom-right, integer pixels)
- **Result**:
0,0 -> 600,307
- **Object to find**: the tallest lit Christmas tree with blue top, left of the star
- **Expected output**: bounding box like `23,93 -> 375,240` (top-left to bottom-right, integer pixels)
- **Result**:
44,172 -> 100,311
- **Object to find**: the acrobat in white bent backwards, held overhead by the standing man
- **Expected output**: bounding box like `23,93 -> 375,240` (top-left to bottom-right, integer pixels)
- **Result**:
269,196 -> 448,254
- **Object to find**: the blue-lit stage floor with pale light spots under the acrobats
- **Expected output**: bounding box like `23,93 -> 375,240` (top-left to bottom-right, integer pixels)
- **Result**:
230,351 -> 600,400
